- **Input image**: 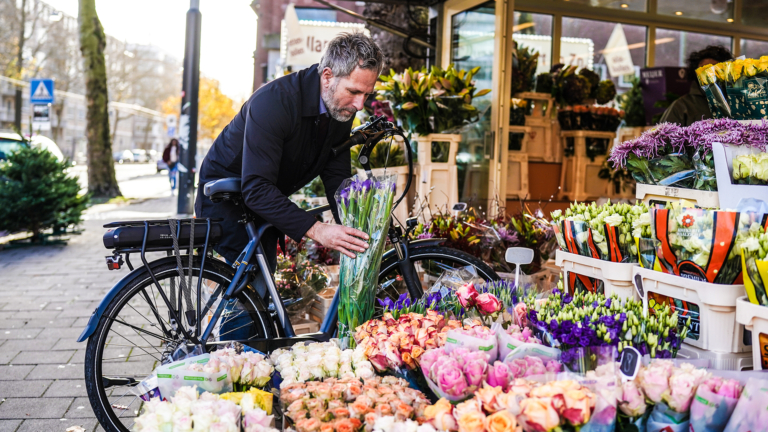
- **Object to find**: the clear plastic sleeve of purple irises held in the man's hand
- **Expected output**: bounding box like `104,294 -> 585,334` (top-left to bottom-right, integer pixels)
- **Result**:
336,175 -> 397,347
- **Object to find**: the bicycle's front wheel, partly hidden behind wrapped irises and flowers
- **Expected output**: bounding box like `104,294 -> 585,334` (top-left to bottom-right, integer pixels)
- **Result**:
376,246 -> 501,316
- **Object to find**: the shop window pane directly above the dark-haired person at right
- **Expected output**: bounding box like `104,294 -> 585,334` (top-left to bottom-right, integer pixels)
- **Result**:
655,28 -> 731,66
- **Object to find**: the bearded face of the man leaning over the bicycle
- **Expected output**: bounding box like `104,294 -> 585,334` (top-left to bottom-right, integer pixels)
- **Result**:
320,68 -> 378,122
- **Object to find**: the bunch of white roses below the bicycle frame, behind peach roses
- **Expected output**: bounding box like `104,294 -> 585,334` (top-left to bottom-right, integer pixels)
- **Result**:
269,339 -> 375,388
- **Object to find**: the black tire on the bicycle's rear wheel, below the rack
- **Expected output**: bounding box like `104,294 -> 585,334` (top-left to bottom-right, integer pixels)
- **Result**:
85,256 -> 276,432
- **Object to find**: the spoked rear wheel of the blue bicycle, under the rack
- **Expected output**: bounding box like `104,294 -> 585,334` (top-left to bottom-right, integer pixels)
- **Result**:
85,256 -> 275,432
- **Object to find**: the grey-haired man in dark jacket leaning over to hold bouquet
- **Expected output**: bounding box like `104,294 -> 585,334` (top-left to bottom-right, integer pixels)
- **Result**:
195,33 -> 383,282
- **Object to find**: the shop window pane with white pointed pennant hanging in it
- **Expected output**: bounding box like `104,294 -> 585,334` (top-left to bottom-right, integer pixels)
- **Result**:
560,17 -> 647,93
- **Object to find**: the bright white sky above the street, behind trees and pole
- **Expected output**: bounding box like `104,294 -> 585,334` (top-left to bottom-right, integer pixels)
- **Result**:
43,0 -> 256,101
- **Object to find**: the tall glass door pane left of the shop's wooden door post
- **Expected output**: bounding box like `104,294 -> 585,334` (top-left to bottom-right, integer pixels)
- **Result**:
450,1 -> 503,212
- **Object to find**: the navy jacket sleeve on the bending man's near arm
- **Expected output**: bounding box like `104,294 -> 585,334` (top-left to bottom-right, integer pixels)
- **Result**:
237,85 -> 316,242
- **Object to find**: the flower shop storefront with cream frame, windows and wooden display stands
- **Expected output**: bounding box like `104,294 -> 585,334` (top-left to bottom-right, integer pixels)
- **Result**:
433,0 -> 768,211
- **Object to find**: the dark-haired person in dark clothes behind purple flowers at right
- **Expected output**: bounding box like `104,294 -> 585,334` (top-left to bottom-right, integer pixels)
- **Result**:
661,45 -> 733,126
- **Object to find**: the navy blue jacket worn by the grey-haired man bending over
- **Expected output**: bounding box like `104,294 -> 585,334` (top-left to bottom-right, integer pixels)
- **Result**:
195,65 -> 352,257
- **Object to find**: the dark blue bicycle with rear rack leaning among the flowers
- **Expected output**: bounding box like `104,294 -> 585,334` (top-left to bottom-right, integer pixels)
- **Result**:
78,117 -> 499,431
